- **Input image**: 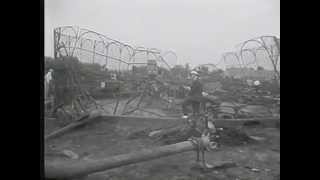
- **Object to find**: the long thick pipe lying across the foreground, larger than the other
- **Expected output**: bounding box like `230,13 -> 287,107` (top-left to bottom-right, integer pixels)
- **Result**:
45,141 -> 195,179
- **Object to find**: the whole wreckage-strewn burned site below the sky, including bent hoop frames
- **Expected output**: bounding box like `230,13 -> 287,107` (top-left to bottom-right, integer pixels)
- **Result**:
44,27 -> 280,180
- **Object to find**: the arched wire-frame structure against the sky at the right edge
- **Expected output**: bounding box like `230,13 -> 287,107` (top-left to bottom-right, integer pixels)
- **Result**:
217,36 -> 280,81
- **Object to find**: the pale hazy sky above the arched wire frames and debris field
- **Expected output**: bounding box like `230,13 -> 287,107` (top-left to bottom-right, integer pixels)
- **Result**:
45,0 -> 280,65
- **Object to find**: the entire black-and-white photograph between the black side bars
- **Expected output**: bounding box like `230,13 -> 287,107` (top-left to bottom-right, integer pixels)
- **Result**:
41,0 -> 280,180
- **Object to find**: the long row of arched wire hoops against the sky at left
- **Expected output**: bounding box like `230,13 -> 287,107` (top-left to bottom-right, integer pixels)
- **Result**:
54,26 -> 177,71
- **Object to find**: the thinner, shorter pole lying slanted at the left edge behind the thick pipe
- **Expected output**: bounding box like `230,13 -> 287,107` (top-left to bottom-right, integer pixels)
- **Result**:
44,111 -> 101,141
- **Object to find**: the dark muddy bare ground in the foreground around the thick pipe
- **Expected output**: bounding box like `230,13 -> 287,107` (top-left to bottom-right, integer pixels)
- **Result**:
45,99 -> 280,180
